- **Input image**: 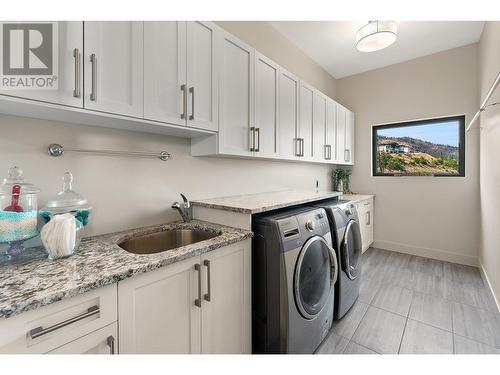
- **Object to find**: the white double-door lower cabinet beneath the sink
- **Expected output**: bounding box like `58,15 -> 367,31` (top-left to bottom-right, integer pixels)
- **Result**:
118,240 -> 251,354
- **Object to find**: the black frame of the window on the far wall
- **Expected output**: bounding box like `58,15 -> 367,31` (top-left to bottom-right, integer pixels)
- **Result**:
372,115 -> 465,177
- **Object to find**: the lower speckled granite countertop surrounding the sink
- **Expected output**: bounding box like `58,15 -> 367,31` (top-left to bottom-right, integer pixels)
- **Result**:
0,220 -> 253,318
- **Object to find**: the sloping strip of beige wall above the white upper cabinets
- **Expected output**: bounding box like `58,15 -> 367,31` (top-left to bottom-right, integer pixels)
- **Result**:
216,21 -> 336,99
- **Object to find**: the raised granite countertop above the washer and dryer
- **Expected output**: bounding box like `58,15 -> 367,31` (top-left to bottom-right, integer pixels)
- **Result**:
191,190 -> 342,214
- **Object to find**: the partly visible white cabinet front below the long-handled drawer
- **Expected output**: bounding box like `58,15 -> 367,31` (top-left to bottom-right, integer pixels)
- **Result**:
47,322 -> 118,354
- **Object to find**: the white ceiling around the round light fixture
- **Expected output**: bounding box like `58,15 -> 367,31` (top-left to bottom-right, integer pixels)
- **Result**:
270,21 -> 484,78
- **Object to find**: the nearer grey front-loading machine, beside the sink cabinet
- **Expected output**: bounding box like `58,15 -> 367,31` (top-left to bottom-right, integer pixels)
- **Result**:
252,208 -> 338,353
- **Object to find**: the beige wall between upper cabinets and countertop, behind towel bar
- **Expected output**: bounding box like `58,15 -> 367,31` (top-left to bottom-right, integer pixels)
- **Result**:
0,115 -> 331,235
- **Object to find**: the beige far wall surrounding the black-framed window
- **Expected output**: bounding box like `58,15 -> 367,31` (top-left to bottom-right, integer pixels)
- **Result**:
337,44 -> 480,264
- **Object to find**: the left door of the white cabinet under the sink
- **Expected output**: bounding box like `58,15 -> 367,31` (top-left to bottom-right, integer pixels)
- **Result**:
118,257 -> 202,354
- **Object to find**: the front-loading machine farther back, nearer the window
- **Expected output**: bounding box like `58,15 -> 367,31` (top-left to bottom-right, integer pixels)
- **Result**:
315,198 -> 362,319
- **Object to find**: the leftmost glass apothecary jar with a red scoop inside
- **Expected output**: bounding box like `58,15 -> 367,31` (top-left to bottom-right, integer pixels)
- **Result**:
0,166 -> 40,257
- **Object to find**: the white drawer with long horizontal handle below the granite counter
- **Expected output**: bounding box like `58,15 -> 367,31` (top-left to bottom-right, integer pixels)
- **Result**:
0,284 -> 117,354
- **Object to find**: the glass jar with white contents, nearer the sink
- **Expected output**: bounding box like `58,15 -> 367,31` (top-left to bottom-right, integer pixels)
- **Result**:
40,172 -> 92,259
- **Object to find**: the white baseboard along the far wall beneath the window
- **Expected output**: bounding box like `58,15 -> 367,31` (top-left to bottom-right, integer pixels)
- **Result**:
372,240 -> 479,267
